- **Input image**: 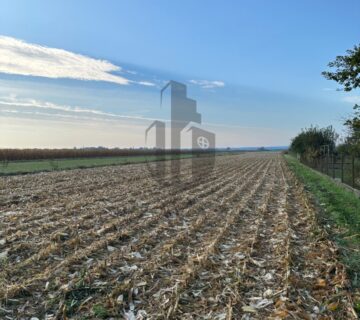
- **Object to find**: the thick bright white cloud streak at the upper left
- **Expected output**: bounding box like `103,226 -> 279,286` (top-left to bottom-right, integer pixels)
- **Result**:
0,36 -> 136,85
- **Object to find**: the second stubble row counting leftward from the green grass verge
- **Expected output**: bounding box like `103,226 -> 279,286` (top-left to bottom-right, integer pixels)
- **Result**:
222,156 -> 289,319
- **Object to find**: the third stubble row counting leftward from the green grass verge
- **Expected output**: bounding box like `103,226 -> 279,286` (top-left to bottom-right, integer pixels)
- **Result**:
169,157 -> 276,319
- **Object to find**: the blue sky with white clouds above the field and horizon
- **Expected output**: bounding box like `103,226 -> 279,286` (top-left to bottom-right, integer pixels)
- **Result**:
0,0 -> 360,148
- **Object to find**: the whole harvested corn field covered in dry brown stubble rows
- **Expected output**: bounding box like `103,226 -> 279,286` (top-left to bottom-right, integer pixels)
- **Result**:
0,153 -> 356,320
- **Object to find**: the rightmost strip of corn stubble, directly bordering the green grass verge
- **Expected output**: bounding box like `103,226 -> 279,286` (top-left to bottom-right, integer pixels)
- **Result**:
272,164 -> 358,320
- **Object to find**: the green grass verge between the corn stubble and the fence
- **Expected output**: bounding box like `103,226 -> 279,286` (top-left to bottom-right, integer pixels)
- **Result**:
285,155 -> 360,313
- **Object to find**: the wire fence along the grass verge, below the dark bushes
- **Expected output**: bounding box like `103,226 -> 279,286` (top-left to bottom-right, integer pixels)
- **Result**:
301,154 -> 360,190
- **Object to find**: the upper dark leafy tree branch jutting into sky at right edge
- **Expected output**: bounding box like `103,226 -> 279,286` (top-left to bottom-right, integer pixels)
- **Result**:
322,45 -> 360,91
